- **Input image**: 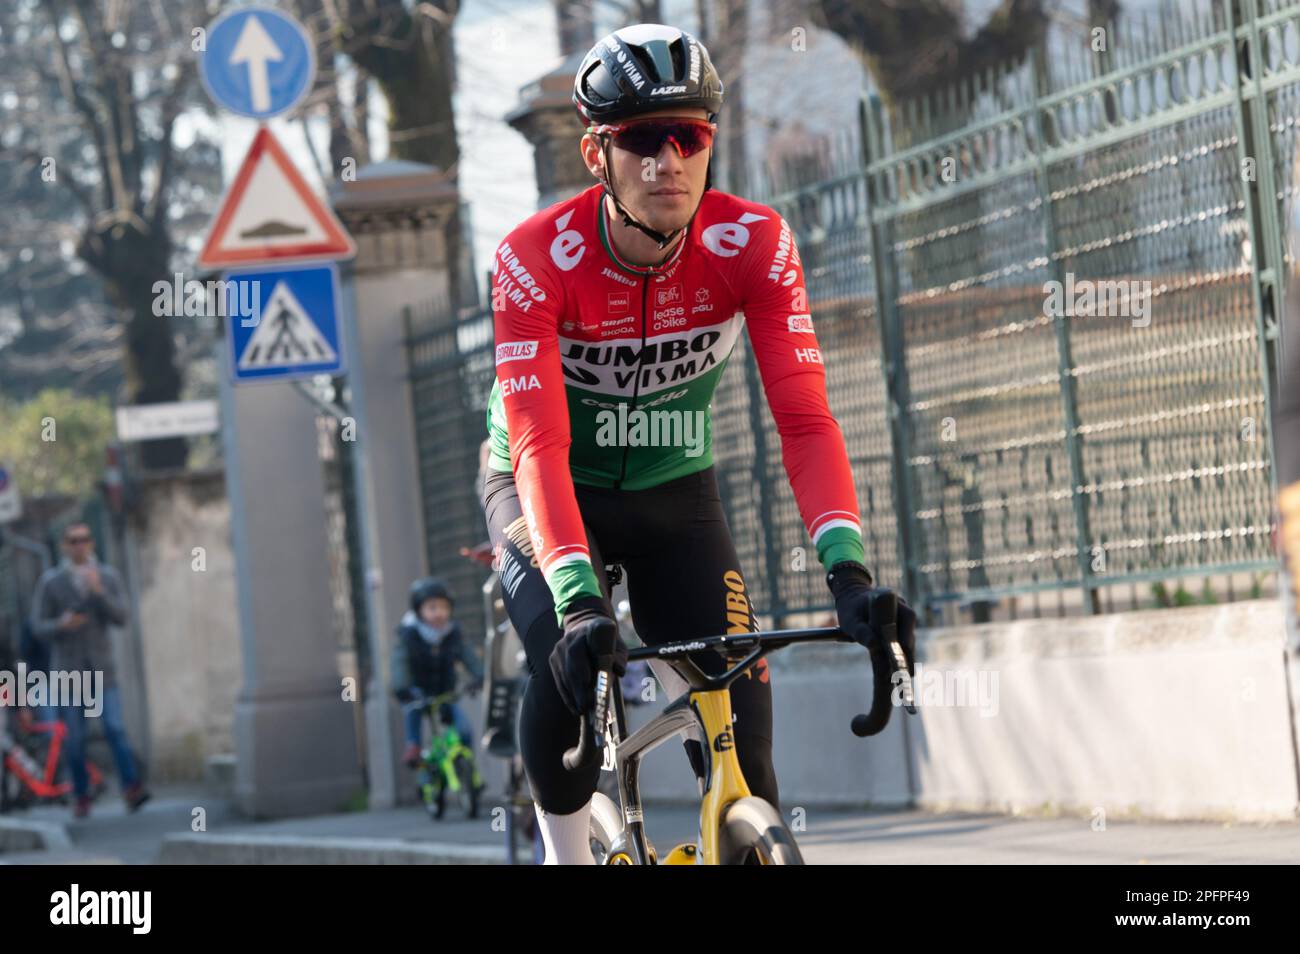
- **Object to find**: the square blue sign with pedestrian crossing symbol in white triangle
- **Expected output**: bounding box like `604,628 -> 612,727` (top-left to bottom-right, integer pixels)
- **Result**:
225,264 -> 346,385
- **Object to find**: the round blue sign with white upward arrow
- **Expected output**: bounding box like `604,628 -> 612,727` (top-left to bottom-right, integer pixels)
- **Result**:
199,6 -> 316,120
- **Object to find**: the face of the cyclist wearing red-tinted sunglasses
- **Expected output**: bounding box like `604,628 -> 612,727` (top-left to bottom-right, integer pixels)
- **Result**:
582,109 -> 712,231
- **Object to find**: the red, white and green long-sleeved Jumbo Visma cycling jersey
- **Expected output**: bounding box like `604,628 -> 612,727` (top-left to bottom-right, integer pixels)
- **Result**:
488,185 -> 865,616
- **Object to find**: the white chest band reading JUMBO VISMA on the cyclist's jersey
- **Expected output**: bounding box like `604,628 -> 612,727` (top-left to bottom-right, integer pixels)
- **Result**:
559,313 -> 741,394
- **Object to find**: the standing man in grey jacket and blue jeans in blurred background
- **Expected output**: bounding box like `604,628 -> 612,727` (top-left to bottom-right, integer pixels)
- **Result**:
31,524 -> 150,818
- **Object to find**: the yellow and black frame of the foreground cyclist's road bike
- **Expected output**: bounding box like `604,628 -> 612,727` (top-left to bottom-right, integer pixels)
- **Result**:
605,628 -> 853,864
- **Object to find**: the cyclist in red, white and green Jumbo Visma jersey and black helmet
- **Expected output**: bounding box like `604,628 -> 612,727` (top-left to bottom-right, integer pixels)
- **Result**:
482,23 -> 915,864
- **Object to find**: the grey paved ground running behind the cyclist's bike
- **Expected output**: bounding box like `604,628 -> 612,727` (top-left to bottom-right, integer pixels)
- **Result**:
0,790 -> 1300,864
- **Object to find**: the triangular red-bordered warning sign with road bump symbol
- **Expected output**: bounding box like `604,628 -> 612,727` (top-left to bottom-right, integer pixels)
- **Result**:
199,126 -> 356,268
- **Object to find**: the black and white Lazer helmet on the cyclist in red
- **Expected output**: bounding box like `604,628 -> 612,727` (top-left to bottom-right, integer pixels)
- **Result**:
573,23 -> 723,123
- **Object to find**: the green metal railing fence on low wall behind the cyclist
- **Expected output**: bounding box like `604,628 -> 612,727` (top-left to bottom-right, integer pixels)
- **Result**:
411,0 -> 1300,629
